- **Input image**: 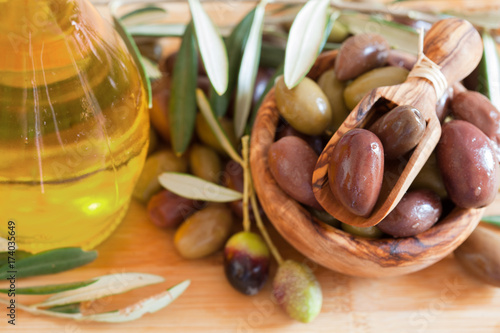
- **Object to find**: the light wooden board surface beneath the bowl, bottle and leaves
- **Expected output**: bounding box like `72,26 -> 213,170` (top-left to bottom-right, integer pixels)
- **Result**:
0,201 -> 500,333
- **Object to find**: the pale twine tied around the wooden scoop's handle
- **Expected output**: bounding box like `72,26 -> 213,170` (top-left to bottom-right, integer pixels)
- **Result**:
408,28 -> 448,99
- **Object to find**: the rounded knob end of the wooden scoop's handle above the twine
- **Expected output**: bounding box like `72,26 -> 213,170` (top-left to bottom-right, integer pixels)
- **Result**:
424,18 -> 483,85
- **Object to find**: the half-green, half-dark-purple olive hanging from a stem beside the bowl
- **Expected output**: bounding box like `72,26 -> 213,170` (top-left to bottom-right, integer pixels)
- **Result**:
224,231 -> 270,295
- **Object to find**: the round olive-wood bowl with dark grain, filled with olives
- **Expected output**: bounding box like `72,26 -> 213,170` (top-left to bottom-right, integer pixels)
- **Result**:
250,51 -> 485,277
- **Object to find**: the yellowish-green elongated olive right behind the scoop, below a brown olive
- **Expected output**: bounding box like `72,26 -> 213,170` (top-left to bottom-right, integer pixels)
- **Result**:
344,66 -> 408,110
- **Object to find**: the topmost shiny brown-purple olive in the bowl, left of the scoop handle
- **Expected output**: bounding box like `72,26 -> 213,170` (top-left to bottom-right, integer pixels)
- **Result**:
335,34 -> 390,81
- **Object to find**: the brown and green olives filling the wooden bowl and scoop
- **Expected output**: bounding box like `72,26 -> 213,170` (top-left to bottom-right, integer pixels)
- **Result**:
268,34 -> 500,238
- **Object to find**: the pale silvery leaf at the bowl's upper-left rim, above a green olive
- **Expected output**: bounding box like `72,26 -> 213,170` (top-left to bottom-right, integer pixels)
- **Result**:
284,0 -> 330,89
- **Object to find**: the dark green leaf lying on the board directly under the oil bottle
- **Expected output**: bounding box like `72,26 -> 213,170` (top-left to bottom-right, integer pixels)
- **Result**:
0,248 -> 97,280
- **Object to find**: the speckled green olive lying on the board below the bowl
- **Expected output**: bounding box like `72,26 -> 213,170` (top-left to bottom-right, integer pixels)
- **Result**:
273,260 -> 323,323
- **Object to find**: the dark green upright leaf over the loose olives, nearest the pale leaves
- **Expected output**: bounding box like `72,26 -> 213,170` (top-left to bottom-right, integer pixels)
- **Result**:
169,24 -> 198,154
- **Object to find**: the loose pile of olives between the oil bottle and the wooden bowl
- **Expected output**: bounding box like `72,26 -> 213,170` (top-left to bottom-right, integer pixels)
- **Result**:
134,53 -> 280,295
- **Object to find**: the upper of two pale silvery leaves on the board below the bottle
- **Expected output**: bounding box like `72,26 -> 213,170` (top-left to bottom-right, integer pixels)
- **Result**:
37,273 -> 165,307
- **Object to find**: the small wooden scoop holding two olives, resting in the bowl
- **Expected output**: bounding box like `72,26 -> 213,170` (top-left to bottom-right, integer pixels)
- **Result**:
313,18 -> 483,227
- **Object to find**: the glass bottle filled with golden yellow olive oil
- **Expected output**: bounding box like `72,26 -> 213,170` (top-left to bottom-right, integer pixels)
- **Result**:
0,0 -> 149,252
